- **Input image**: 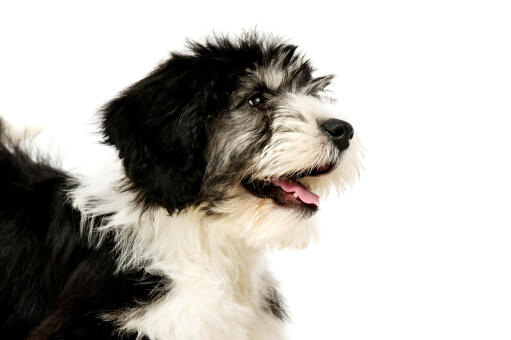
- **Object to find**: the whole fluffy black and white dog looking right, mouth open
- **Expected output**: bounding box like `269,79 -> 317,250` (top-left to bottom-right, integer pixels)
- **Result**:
0,33 -> 361,340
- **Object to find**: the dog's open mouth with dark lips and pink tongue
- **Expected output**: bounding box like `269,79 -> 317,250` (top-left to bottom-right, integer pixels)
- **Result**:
242,164 -> 334,213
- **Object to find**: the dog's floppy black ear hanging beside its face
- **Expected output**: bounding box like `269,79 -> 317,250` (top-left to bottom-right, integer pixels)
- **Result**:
102,54 -> 227,214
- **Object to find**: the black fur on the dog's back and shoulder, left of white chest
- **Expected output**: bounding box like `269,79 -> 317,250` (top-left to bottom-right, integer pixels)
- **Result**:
0,137 -> 167,339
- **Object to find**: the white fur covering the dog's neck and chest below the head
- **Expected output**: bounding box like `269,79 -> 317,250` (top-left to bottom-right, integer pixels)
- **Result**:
70,155 -> 290,340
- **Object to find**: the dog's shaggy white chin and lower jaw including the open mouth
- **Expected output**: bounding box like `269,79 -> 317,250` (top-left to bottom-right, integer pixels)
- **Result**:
204,164 -> 340,249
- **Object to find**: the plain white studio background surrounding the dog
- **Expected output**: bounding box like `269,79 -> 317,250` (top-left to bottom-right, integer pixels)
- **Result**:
0,1 -> 511,340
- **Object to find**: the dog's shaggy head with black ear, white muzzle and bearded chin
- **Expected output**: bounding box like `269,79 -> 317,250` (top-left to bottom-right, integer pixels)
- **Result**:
102,34 -> 360,247
